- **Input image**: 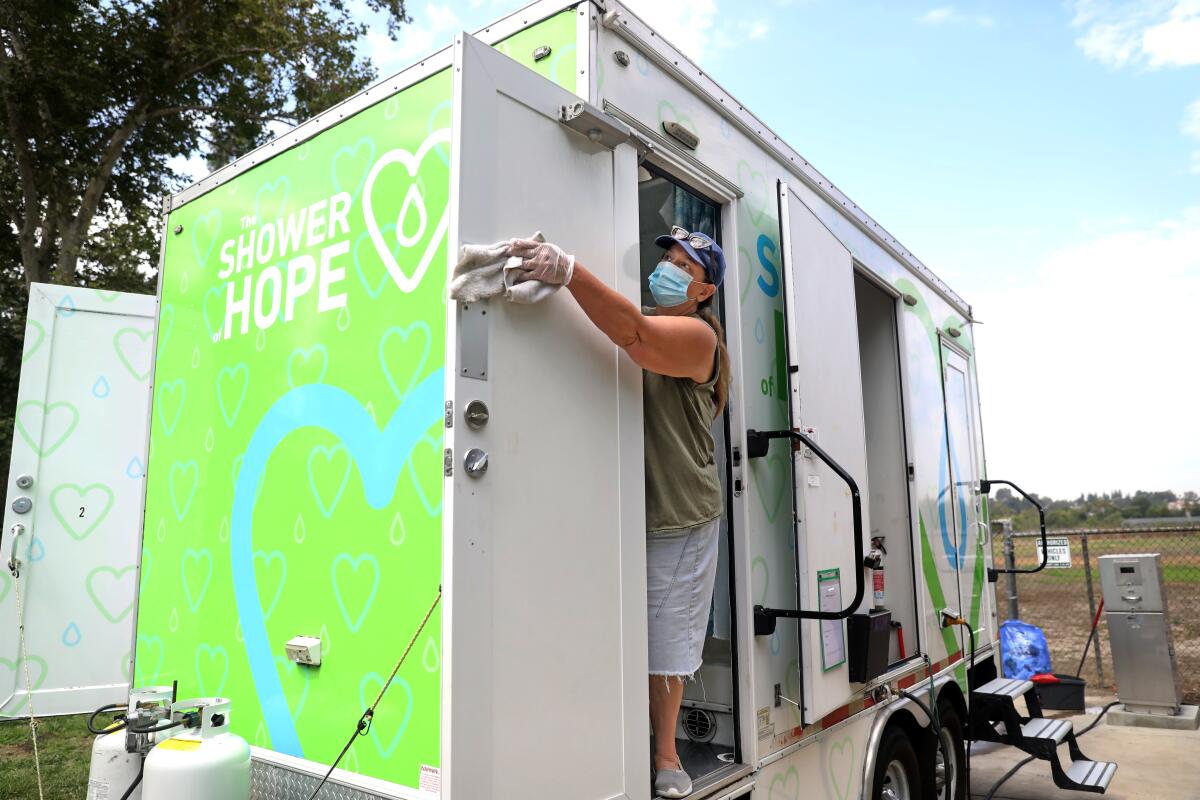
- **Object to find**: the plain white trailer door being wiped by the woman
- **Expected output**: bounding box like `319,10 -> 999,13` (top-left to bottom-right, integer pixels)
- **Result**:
442,34 -> 649,800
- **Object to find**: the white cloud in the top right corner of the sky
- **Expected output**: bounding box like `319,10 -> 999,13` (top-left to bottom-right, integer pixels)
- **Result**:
1072,0 -> 1200,70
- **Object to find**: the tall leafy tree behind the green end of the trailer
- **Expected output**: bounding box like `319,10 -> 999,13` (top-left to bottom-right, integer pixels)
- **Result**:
0,0 -> 408,285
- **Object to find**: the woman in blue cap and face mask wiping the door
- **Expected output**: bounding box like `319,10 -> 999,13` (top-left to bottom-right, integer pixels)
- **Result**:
511,227 -> 730,798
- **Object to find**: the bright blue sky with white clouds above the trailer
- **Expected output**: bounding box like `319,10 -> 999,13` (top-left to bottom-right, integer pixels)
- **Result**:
338,0 -> 1200,497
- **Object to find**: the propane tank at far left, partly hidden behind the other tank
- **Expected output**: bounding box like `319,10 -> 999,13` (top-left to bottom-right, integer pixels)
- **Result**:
88,686 -> 173,800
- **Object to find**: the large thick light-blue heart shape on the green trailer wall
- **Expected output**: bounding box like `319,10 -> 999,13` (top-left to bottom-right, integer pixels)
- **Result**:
229,369 -> 444,758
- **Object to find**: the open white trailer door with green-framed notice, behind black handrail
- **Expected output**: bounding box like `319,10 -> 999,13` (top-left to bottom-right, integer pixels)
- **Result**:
776,182 -> 871,724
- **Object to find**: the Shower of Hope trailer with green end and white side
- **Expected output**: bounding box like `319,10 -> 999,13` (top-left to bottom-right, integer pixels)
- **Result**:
108,0 -> 1115,800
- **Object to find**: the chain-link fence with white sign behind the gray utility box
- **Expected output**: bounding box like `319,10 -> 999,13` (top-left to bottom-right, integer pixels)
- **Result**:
991,524 -> 1200,703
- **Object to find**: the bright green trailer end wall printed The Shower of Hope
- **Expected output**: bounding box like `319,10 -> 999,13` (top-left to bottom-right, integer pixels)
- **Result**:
134,11 -> 576,787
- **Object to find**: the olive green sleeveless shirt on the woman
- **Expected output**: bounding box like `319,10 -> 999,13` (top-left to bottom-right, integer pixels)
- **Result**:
642,317 -> 725,534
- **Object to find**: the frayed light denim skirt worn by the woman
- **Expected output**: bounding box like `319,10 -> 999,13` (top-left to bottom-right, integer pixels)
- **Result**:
646,517 -> 721,678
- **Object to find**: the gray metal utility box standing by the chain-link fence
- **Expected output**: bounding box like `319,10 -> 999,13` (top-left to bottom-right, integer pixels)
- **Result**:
1100,553 -> 1182,715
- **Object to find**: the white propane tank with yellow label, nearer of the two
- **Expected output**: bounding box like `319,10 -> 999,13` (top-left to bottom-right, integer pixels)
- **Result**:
142,697 -> 250,800
